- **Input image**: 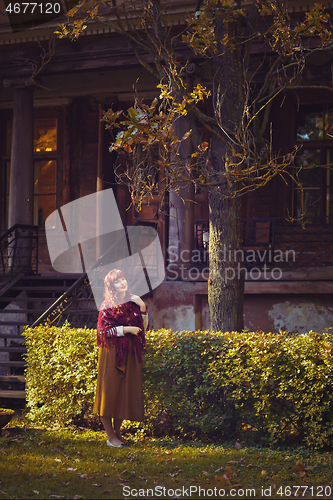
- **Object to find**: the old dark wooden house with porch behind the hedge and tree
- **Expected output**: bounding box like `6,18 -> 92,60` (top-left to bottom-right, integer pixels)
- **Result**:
0,0 -> 333,394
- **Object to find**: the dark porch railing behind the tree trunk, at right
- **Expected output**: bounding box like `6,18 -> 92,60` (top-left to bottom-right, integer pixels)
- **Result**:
195,217 -> 333,268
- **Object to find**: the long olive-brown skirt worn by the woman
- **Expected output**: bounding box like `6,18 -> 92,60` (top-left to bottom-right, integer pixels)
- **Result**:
93,346 -> 144,422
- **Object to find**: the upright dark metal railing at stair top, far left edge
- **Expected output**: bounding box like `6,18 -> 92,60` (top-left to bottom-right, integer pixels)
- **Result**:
0,224 -> 38,282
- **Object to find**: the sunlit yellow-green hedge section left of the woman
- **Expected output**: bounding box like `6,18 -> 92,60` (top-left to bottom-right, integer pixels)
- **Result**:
24,325 -> 98,426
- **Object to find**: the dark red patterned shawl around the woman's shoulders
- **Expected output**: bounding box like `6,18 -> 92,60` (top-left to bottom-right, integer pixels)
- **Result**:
97,300 -> 145,366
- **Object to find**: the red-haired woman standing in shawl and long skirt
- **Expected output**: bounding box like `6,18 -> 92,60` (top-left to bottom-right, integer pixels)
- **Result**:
93,269 -> 148,446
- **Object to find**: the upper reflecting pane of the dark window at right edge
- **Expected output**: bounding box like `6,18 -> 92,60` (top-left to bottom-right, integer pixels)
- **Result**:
296,104 -> 324,141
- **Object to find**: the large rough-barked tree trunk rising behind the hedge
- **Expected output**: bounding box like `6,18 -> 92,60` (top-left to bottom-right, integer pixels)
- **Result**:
208,12 -> 245,332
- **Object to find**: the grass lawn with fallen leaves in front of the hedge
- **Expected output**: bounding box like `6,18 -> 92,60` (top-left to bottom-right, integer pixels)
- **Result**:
0,420 -> 333,500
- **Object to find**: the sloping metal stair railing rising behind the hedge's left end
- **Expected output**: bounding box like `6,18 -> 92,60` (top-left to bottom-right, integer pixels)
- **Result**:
31,224 -> 160,328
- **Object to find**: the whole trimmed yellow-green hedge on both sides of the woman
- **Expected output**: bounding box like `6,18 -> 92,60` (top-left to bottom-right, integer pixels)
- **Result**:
25,325 -> 333,447
